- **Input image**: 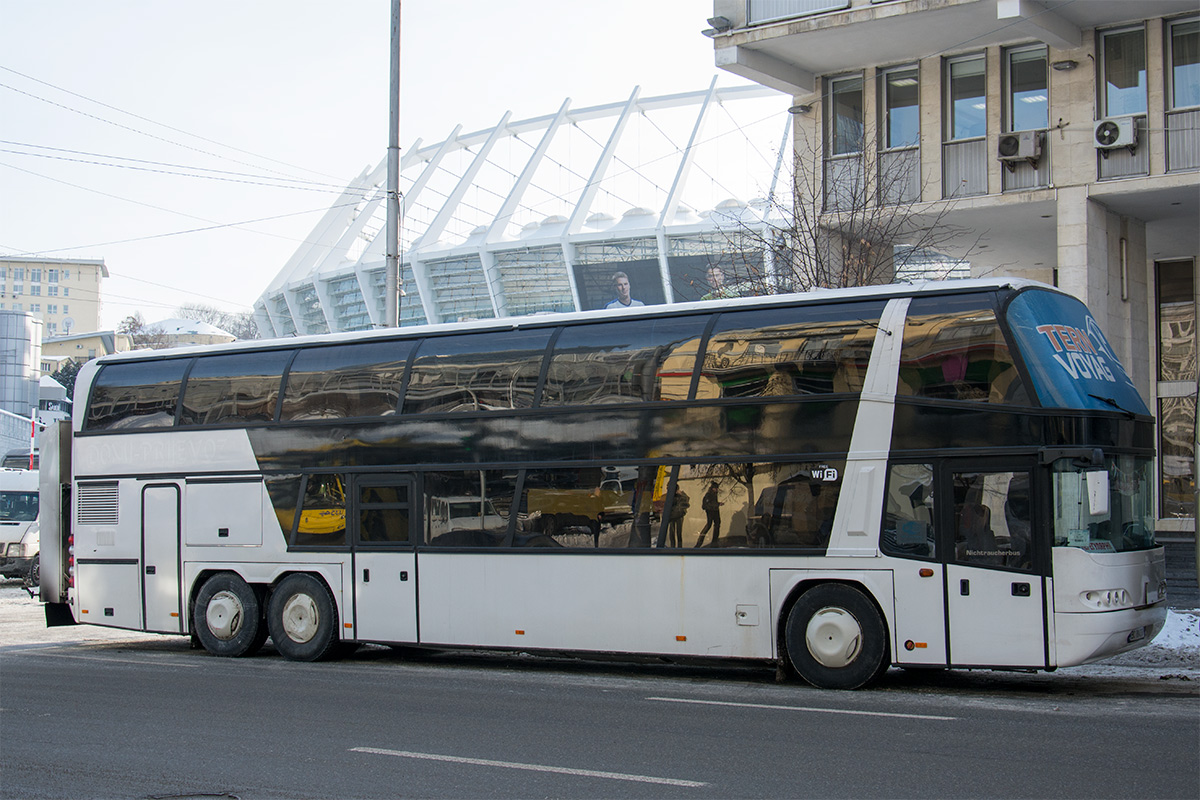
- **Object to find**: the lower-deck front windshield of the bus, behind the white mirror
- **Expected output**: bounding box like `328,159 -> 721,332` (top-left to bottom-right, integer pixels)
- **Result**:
1051,456 -> 1154,553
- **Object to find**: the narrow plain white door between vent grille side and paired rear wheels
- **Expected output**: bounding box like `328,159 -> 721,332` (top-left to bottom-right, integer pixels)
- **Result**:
142,483 -> 184,633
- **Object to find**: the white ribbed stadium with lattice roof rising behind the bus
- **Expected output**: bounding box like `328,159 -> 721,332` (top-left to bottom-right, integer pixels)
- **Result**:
254,78 -> 793,337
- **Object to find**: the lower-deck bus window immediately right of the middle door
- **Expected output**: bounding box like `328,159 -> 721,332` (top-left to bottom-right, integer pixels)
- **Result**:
425,470 -> 516,547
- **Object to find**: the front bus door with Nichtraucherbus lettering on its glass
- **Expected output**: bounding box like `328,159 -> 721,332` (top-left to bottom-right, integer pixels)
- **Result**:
941,461 -> 1046,667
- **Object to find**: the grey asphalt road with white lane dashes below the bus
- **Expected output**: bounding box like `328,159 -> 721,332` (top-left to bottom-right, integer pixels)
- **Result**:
0,638 -> 1200,799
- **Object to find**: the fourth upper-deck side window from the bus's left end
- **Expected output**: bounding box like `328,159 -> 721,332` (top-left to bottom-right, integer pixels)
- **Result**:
403,327 -> 552,414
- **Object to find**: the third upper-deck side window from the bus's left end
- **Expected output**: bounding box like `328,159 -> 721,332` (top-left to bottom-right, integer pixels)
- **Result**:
280,342 -> 413,422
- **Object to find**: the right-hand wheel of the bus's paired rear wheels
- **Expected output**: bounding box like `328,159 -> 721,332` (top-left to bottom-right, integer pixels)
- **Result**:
266,572 -> 338,661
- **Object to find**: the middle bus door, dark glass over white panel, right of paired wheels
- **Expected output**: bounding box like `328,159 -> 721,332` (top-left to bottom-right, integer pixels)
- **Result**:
350,475 -> 420,643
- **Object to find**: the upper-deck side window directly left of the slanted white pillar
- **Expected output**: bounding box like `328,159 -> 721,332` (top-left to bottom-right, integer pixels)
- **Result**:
696,302 -> 883,399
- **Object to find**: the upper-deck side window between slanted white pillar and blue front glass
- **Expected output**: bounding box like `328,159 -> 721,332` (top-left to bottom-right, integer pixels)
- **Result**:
896,296 -> 1030,405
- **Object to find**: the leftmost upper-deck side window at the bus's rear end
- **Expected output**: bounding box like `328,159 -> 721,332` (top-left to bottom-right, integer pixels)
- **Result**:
84,359 -> 192,431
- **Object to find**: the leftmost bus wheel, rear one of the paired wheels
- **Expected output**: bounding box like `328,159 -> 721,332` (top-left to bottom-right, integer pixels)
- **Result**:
192,572 -> 266,658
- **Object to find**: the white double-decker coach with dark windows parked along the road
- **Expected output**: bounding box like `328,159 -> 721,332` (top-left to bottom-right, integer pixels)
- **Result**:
42,281 -> 1166,688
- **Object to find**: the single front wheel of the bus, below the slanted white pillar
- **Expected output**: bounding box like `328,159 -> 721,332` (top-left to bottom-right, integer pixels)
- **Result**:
784,583 -> 888,688
